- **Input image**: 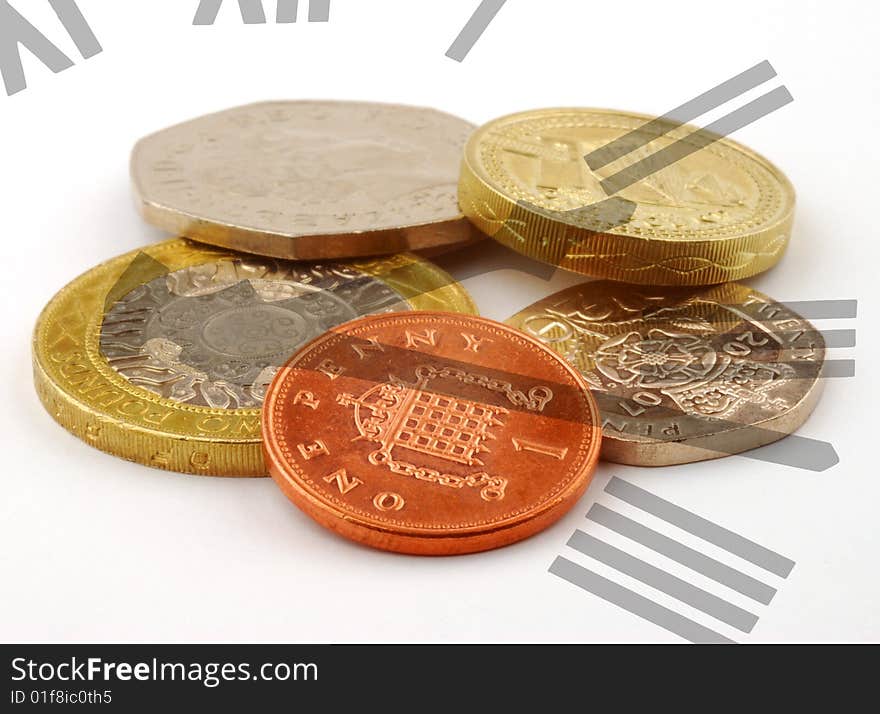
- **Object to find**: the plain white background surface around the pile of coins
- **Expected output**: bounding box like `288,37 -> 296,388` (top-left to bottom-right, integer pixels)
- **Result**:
0,0 -> 880,642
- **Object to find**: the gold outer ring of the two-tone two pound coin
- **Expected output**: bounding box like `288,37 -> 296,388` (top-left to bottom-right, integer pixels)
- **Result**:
33,239 -> 476,476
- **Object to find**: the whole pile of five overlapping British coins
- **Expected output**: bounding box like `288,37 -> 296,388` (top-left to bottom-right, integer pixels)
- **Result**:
33,101 -> 825,554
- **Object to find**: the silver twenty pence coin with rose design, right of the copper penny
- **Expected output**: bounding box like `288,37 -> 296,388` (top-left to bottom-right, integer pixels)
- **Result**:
508,281 -> 824,463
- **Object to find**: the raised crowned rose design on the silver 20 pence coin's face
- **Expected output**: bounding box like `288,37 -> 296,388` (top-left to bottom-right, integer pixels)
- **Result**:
526,291 -> 795,417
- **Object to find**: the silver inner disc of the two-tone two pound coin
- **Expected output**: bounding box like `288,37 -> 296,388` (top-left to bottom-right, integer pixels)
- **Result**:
100,259 -> 409,409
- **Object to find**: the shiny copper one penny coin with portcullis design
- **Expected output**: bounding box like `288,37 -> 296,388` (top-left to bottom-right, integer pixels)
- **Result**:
263,312 -> 601,555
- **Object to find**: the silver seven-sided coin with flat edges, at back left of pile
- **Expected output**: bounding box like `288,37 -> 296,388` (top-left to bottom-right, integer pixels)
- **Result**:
132,101 -> 482,259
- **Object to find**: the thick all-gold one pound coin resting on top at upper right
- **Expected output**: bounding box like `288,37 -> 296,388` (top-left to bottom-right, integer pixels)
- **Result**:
459,109 -> 795,285
